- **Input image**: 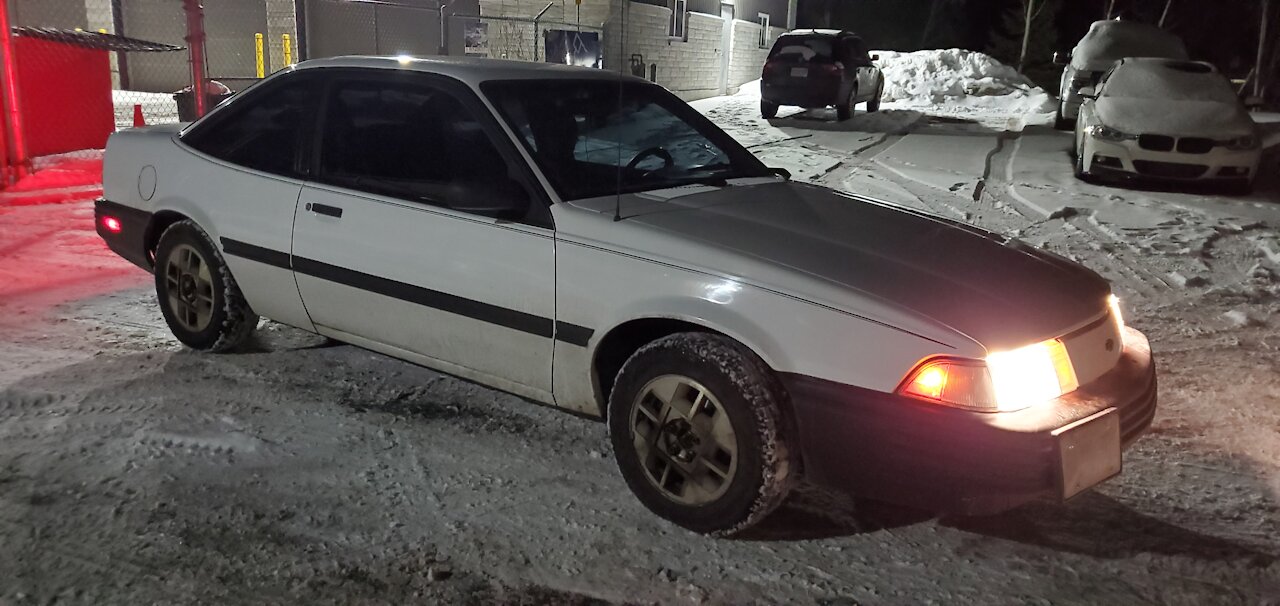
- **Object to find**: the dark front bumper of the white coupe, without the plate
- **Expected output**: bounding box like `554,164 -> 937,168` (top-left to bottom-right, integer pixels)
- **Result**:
783,328 -> 1156,515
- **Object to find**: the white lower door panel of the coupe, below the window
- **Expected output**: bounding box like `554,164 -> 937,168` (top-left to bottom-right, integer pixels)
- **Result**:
293,184 -> 556,400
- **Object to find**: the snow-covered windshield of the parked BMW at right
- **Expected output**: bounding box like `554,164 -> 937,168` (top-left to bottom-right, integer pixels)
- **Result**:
1102,61 -> 1239,105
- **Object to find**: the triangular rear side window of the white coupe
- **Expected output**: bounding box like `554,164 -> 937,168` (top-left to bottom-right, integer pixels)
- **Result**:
182,76 -> 319,177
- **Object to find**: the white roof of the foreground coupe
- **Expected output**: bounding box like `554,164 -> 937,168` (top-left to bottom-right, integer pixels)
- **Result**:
294,55 -> 649,86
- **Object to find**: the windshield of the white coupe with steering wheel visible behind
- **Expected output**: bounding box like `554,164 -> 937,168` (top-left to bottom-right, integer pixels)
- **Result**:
481,79 -> 772,200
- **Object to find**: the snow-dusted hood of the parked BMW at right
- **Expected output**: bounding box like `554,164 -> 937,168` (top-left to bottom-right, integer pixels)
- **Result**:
1096,97 -> 1256,140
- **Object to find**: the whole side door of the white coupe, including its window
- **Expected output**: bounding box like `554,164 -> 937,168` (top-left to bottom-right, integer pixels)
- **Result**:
293,69 -> 556,401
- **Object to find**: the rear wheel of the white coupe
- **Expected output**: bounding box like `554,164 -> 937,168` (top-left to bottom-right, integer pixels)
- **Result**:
155,220 -> 257,351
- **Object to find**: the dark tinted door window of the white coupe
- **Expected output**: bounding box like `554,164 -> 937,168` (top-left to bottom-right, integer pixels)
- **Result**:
320,78 -> 518,215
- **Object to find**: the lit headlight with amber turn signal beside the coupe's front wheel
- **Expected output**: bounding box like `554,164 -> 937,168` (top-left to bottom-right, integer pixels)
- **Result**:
897,340 -> 1080,413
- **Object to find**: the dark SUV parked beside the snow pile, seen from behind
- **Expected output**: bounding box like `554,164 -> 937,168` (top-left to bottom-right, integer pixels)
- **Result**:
760,29 -> 884,120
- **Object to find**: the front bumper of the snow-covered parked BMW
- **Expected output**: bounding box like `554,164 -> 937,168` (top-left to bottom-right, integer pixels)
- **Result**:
1084,136 -> 1262,182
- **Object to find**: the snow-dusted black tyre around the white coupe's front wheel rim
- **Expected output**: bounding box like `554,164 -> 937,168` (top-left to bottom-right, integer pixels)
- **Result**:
608,333 -> 799,536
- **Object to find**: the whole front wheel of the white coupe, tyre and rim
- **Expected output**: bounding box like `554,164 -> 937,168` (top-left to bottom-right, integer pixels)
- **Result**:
609,333 -> 796,534
